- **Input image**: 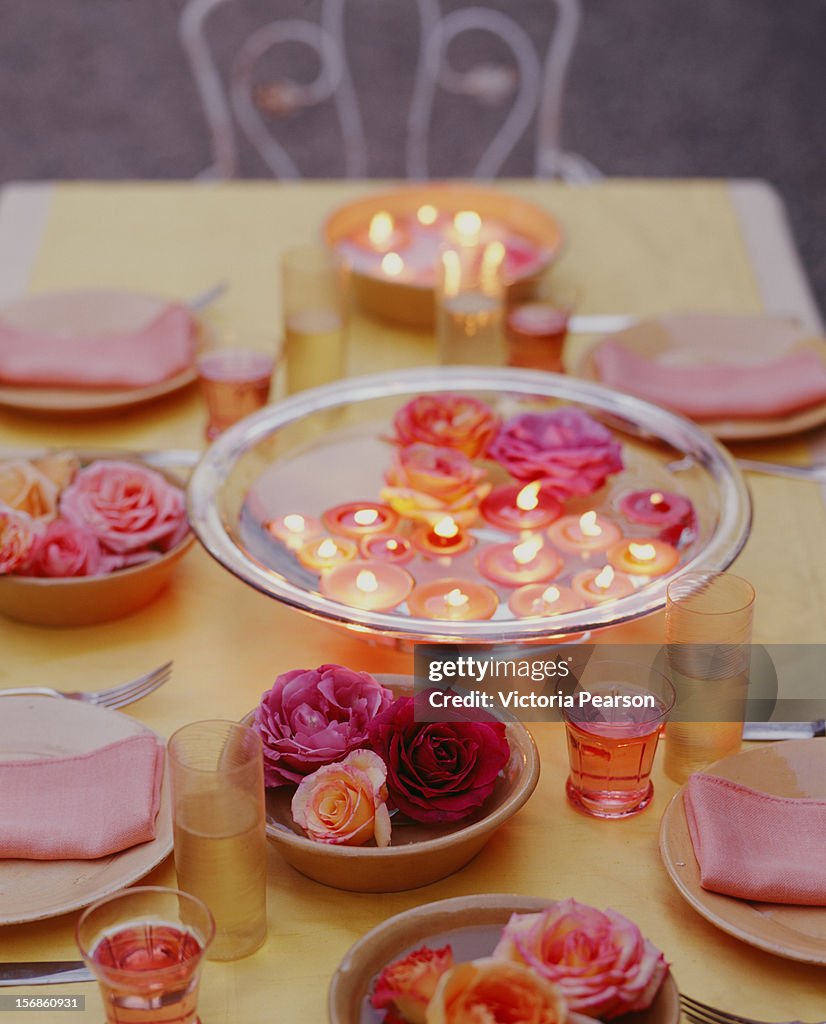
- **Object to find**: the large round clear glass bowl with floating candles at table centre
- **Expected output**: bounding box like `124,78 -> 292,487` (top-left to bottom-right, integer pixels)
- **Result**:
188,366 -> 750,644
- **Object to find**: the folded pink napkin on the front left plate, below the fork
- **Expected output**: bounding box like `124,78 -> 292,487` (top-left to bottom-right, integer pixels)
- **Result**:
0,733 -> 164,860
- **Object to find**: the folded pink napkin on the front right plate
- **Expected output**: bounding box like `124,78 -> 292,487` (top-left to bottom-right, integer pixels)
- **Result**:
684,770 -> 826,906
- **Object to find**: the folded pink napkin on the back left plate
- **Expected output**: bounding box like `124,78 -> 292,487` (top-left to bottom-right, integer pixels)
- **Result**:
0,304 -> 195,387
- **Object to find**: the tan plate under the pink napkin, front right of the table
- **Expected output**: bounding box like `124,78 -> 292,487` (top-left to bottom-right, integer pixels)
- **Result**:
659,739 -> 826,967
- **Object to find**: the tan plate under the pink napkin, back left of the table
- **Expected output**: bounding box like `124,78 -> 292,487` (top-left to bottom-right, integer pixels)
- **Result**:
0,290 -> 197,413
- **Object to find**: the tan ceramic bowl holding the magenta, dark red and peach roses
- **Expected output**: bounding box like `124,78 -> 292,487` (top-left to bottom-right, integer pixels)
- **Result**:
244,676 -> 539,893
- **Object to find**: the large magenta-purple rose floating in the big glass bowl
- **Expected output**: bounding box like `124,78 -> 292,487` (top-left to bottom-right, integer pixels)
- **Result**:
487,406 -> 622,501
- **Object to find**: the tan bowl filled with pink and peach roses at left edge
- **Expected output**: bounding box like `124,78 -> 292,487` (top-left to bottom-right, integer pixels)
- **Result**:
0,451 -> 194,627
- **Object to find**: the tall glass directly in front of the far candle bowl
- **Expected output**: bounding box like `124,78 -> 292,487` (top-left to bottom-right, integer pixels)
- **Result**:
436,242 -> 505,366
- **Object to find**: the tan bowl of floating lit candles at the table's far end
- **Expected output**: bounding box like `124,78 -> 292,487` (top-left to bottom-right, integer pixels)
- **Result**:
324,182 -> 562,328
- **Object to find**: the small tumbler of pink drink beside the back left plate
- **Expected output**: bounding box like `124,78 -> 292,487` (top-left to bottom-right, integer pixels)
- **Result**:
197,331 -> 275,440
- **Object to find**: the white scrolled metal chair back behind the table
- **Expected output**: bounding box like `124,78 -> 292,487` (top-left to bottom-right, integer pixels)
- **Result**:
180,0 -> 600,181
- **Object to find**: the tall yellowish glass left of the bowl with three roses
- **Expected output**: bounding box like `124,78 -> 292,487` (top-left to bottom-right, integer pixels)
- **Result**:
168,720 -> 267,961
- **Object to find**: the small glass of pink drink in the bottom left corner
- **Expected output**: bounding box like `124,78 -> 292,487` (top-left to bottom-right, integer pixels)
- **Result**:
75,886 -> 215,1024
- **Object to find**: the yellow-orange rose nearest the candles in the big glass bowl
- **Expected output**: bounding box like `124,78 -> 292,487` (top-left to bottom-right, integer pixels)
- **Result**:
382,443 -> 490,526
